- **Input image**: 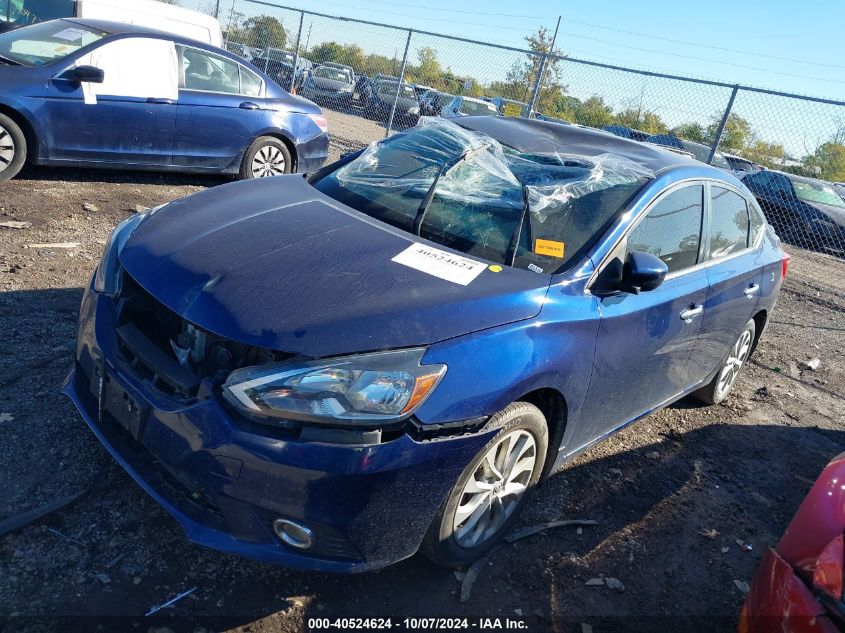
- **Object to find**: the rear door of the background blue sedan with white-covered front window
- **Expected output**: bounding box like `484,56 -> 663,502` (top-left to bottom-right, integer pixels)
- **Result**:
173,46 -> 268,169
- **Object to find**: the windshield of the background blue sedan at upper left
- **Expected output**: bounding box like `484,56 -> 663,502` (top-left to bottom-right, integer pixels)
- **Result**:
0,20 -> 108,66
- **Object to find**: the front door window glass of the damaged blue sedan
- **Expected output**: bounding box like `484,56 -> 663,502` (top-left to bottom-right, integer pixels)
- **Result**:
627,185 -> 704,273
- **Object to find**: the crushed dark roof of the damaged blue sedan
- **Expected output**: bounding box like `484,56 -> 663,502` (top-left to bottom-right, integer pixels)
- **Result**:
455,116 -> 704,173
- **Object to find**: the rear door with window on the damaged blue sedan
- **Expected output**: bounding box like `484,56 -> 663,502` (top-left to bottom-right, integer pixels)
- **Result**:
690,183 -> 763,382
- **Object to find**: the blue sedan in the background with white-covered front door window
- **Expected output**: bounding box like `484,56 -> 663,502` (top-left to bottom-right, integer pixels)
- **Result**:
0,20 -> 329,180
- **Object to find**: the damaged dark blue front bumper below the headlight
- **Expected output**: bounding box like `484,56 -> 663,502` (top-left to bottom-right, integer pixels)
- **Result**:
63,289 -> 491,572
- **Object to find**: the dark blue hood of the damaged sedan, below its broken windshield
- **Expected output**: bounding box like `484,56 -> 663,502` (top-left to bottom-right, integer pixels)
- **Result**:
120,175 -> 551,357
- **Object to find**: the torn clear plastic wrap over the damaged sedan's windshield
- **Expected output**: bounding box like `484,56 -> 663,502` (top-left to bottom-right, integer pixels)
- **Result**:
336,117 -> 654,237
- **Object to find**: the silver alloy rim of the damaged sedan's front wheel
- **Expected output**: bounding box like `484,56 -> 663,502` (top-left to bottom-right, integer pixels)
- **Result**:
453,429 -> 537,548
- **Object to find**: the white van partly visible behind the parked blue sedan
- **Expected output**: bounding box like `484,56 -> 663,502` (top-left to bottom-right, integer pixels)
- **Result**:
0,0 -> 223,47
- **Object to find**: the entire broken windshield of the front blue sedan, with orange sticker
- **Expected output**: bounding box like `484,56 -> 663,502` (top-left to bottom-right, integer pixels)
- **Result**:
315,118 -> 653,273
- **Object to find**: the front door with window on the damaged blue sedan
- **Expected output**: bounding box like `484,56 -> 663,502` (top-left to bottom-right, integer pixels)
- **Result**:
576,184 -> 708,444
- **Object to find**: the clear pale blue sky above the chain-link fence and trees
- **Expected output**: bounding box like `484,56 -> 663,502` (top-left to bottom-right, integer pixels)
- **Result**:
199,0 -> 845,154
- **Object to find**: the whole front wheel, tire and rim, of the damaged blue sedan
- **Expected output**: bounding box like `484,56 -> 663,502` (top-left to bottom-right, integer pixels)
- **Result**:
421,402 -> 549,567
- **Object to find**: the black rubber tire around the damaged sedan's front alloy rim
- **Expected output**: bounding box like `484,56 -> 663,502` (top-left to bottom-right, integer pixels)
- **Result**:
420,402 -> 549,568
